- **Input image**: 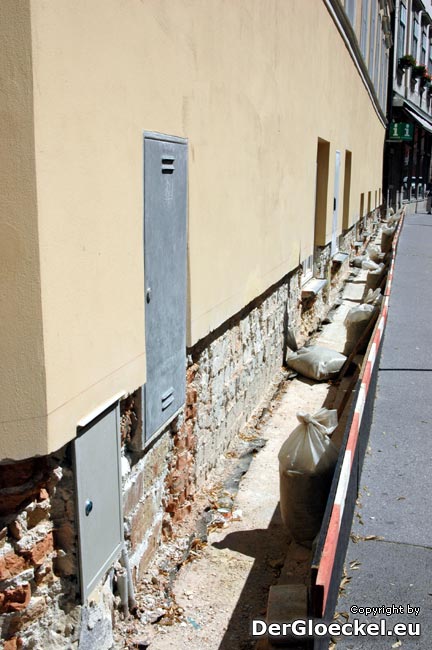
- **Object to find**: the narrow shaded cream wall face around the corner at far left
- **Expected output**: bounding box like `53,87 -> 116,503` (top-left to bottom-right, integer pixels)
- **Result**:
0,0 -> 46,459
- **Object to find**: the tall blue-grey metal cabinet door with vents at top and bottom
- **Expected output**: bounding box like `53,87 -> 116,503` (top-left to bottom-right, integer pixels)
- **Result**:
144,136 -> 187,441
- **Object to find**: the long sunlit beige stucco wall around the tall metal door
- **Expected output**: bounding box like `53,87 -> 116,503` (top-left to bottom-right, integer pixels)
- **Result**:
0,0 -> 384,456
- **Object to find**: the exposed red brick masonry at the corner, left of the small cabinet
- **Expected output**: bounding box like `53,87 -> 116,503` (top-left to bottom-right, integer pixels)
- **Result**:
0,449 -> 78,649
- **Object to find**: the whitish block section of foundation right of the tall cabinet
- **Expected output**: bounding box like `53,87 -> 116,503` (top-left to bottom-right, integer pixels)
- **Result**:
191,276 -> 297,485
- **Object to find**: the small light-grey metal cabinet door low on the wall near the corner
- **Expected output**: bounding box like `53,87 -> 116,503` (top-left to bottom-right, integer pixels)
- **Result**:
74,406 -> 123,601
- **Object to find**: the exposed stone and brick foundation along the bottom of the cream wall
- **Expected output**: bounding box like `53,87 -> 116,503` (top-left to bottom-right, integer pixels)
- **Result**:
0,211 -> 384,650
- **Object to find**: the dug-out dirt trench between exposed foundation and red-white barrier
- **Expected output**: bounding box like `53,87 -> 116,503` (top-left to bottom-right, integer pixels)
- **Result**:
114,214 -> 403,650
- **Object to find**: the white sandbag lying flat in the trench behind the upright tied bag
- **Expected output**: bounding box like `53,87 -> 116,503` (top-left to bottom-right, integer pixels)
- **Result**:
287,345 -> 346,381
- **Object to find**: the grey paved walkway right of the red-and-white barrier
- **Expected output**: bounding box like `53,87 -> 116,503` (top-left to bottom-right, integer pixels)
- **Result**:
337,213 -> 432,650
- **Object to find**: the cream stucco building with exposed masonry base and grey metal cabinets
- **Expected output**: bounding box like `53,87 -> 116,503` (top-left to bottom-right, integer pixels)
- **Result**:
0,0 -> 393,648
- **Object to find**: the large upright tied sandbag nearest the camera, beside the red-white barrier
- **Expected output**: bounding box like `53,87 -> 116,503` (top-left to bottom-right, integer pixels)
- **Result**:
278,408 -> 338,547
